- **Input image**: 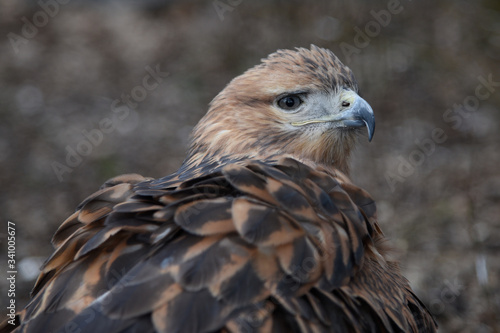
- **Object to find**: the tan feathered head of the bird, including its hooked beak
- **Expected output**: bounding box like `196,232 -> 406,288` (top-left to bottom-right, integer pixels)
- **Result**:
188,45 -> 375,172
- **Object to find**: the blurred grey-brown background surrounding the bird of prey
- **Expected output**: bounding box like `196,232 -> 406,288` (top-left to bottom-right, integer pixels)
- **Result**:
0,0 -> 500,332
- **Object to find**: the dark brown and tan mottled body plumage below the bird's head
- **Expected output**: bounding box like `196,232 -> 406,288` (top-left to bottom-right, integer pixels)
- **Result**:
9,158 -> 431,332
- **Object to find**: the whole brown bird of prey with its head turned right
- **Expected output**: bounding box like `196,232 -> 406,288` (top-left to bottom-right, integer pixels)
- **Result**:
3,45 -> 437,333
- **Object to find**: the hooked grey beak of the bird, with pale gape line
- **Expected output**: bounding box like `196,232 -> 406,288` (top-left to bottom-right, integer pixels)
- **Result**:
292,91 -> 375,141
